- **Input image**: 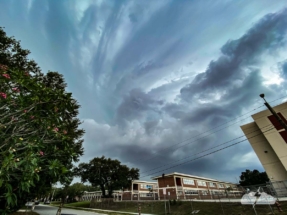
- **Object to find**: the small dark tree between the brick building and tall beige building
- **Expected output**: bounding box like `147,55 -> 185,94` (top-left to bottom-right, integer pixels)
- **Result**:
239,169 -> 269,186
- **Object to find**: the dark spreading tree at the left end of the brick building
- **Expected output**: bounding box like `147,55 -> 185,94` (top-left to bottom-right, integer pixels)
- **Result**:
74,156 -> 139,197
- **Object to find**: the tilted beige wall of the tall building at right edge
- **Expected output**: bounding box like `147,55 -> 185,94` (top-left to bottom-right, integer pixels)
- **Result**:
241,103 -> 287,181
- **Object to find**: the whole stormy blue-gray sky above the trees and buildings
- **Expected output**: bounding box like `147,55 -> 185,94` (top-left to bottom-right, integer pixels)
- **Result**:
0,0 -> 287,182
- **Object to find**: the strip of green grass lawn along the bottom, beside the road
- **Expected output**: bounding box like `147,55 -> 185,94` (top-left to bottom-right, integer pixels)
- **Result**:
65,201 -> 287,215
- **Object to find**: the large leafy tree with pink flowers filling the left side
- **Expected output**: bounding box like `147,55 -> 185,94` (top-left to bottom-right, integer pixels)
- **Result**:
0,28 -> 84,214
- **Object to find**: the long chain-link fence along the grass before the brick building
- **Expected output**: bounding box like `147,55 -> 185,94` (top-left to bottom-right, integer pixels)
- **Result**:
84,181 -> 287,215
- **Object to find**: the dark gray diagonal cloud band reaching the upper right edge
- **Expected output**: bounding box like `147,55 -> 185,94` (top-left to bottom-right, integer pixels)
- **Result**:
181,9 -> 287,101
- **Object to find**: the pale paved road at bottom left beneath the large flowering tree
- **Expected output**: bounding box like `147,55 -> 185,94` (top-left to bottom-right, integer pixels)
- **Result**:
34,204 -> 102,215
